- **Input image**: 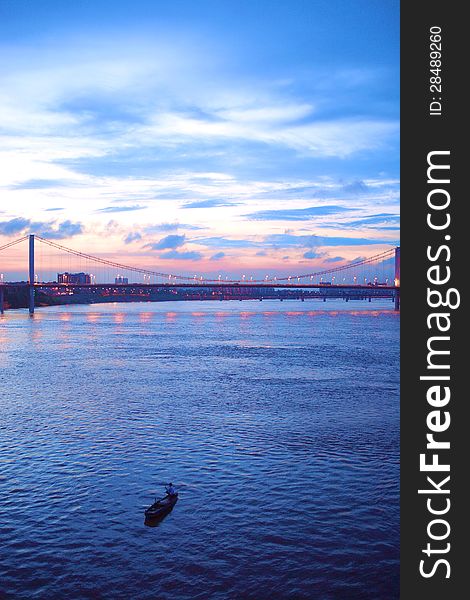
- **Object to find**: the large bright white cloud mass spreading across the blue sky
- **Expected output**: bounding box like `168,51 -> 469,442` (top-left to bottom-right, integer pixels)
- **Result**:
0,32 -> 398,260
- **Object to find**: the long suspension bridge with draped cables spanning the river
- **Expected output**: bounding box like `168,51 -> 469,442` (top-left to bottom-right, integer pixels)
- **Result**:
0,234 -> 400,314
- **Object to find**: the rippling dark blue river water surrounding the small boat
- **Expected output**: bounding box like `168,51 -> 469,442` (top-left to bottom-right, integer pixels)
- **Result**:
0,301 -> 399,600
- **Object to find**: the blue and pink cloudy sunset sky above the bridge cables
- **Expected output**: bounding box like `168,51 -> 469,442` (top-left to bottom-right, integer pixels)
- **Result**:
0,0 -> 399,276
